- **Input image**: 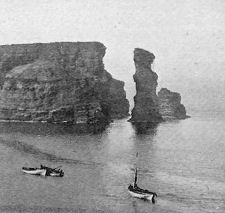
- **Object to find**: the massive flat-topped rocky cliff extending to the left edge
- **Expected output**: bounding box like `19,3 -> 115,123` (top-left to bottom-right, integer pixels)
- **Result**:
0,42 -> 129,124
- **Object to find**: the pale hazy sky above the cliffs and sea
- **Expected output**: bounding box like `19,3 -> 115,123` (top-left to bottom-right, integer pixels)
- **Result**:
0,0 -> 225,110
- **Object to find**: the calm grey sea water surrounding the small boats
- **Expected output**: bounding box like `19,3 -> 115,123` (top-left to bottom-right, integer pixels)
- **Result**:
0,114 -> 225,213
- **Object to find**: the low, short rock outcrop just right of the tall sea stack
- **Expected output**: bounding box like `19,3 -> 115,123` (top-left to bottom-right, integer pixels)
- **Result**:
158,88 -> 187,119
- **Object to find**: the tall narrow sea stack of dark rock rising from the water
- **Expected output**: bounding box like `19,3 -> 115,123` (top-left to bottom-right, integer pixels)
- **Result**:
130,48 -> 162,123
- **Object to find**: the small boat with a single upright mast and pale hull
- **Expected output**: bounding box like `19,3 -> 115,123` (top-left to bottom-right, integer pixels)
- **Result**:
128,153 -> 157,203
